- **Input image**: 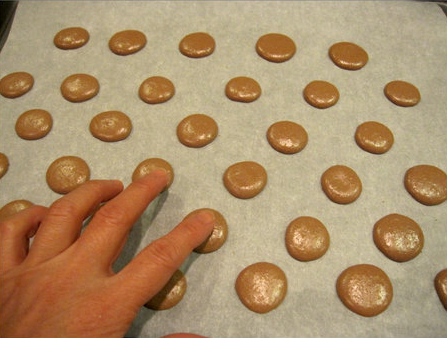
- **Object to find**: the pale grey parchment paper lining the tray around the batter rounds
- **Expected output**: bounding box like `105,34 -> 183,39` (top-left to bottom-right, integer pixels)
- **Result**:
0,1 -> 447,337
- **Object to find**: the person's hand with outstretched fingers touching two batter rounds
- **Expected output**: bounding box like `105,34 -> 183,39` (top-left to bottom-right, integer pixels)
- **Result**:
0,170 -> 213,337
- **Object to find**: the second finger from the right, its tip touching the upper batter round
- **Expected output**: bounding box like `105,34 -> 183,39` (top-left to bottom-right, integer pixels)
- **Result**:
77,170 -> 168,270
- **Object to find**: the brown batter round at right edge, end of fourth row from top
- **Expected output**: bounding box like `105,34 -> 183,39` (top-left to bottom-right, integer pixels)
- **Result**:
404,165 -> 447,205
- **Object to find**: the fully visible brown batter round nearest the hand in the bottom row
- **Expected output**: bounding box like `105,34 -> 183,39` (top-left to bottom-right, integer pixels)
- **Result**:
236,262 -> 287,313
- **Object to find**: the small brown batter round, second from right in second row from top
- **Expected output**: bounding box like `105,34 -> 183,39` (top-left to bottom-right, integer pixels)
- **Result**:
303,80 -> 340,109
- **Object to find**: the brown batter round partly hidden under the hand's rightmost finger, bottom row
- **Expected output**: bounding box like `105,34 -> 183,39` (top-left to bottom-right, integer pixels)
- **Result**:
145,270 -> 187,311
